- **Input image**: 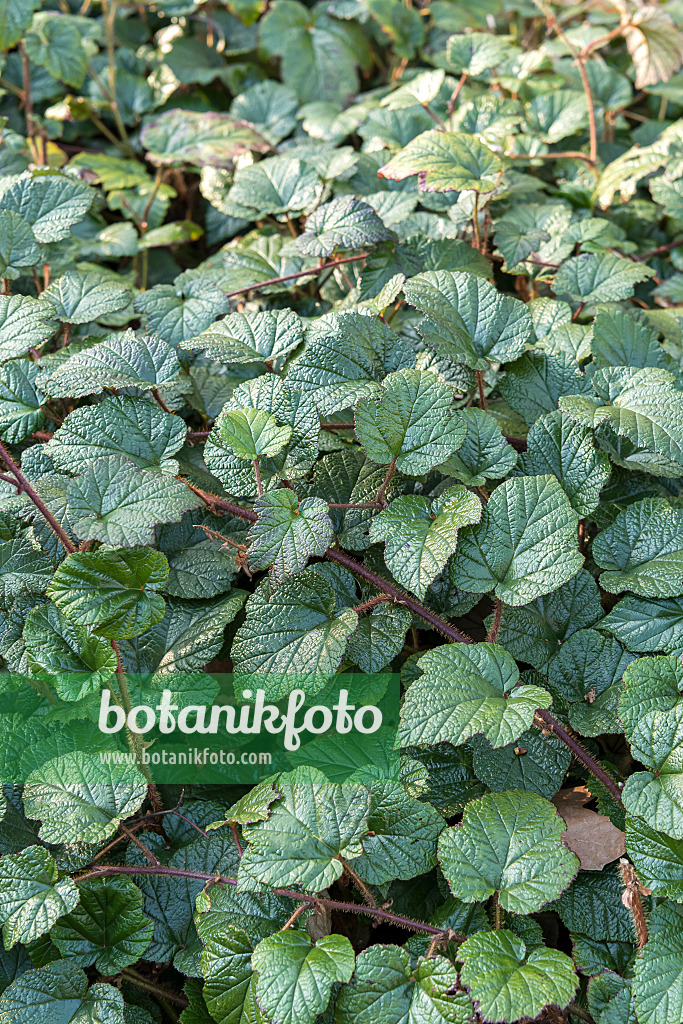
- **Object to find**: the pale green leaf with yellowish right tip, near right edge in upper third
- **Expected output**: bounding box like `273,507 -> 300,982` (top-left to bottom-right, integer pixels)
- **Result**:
553,253 -> 654,304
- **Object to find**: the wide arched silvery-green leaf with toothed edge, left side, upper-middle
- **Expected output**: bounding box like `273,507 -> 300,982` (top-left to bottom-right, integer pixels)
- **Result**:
43,335 -> 180,398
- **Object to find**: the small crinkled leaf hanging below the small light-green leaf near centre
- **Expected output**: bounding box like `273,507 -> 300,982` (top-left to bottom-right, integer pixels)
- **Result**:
249,487 -> 333,584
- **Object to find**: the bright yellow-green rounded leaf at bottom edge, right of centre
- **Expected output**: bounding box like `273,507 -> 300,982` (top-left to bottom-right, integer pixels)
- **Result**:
458,929 -> 579,1021
